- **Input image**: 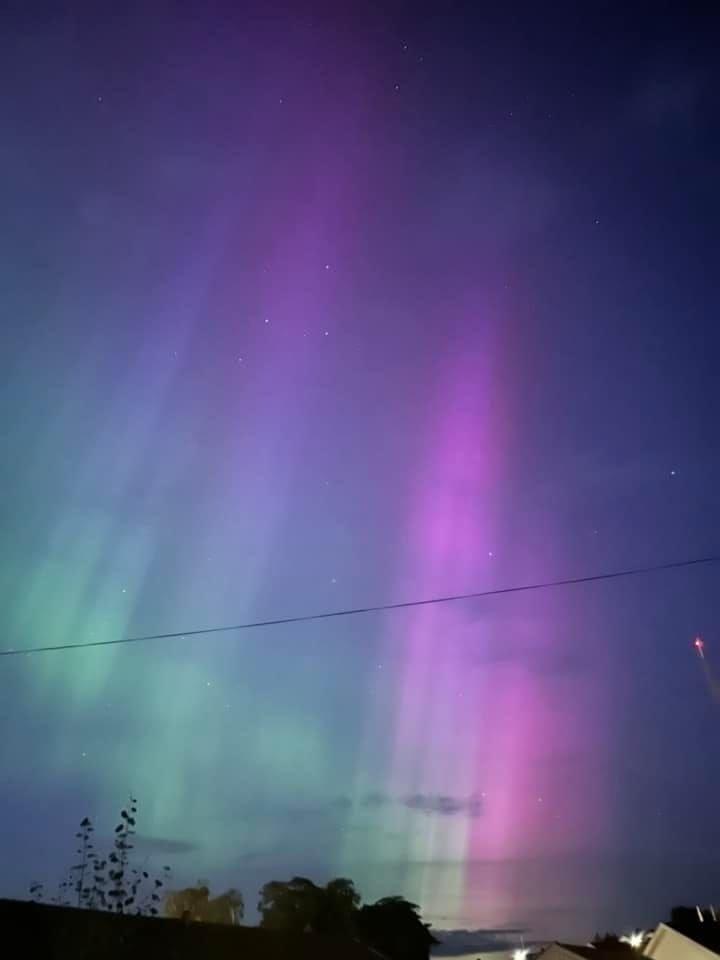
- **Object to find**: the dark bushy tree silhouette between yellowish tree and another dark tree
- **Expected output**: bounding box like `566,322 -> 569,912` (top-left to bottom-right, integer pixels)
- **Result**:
258,877 -> 360,936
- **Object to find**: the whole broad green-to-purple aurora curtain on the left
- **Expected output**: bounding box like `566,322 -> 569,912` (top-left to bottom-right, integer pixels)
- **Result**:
0,80 -> 382,879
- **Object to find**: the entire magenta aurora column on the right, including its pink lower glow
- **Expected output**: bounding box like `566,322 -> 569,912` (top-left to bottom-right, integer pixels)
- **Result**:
352,326 -> 607,925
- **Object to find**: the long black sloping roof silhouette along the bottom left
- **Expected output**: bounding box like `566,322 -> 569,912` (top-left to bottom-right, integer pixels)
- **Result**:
0,900 -> 378,960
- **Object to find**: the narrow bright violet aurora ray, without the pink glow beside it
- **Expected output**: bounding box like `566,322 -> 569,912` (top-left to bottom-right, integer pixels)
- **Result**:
382,349 -> 506,920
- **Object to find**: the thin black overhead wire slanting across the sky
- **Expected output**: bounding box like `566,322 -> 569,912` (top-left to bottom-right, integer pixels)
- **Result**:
0,556 -> 720,657
